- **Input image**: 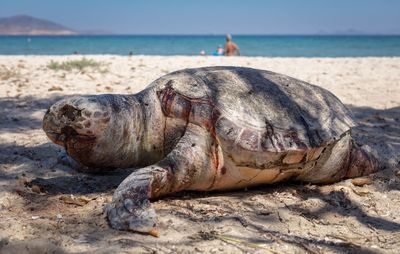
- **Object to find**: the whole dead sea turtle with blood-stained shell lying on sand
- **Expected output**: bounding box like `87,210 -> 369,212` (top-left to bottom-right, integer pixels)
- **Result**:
43,67 -> 378,232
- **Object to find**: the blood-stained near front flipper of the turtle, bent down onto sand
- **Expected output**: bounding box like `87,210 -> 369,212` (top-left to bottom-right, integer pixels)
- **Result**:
106,124 -> 219,234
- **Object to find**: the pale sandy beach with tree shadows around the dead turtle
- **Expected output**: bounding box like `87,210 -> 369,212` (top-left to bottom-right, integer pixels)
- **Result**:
0,55 -> 400,253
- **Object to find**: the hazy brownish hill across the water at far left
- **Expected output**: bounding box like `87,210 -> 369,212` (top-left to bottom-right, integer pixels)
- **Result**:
0,15 -> 78,35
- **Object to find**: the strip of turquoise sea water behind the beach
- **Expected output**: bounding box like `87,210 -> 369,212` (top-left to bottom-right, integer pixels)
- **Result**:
0,35 -> 400,57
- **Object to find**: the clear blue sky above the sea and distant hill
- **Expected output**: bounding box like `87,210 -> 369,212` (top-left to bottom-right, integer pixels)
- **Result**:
0,0 -> 400,34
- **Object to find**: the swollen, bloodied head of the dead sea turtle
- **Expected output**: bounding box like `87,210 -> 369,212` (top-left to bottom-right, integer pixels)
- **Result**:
43,95 -> 140,169
